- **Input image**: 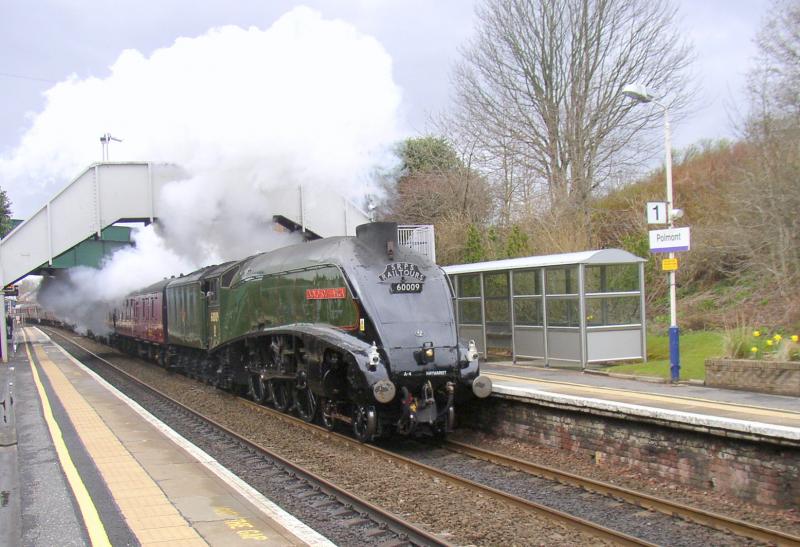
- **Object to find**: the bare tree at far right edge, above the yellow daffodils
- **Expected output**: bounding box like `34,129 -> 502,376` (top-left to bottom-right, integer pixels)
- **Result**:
719,0 -> 800,296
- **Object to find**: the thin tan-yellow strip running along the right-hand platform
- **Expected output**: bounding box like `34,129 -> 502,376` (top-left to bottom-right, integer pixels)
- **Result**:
484,372 -> 800,419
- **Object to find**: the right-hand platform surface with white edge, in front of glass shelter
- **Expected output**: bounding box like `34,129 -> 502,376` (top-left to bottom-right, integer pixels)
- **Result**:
481,362 -> 800,446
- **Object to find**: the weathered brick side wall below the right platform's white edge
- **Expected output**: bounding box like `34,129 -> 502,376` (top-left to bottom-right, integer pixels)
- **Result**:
460,397 -> 800,508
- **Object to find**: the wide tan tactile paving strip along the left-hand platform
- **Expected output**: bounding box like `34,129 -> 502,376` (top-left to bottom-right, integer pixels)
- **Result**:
27,330 -> 207,546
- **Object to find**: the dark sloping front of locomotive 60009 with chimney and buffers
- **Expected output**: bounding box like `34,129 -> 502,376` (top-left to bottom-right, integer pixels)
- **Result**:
340,223 -> 491,435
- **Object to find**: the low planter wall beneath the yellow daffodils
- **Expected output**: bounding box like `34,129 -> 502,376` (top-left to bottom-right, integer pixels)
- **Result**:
706,359 -> 800,397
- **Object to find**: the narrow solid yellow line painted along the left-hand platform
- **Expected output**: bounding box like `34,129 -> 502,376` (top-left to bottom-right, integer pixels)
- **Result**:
23,331 -> 111,547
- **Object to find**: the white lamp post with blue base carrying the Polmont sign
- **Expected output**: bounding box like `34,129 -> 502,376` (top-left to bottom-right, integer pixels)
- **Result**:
622,84 -> 681,382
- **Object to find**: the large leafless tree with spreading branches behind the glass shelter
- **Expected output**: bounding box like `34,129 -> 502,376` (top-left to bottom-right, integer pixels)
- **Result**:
454,0 -> 691,230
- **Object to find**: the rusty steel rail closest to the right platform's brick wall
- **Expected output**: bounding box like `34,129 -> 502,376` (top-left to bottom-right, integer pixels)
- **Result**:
445,441 -> 800,547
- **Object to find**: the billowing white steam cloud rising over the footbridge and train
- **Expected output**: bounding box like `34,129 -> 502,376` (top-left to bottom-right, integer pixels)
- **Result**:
0,7 -> 401,329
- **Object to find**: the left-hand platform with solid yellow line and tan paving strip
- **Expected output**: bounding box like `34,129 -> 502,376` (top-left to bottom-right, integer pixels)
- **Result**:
0,327 -> 332,546
